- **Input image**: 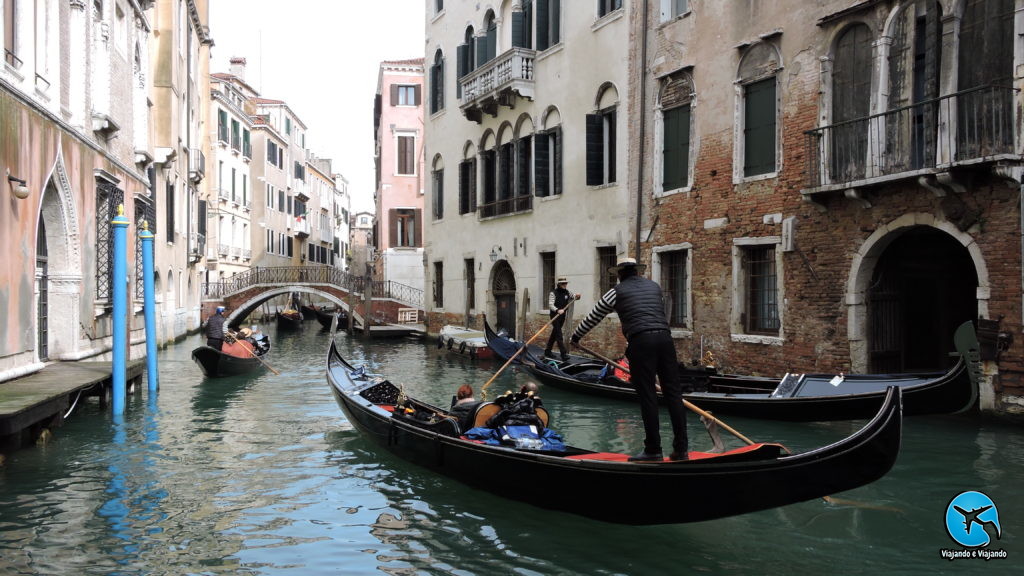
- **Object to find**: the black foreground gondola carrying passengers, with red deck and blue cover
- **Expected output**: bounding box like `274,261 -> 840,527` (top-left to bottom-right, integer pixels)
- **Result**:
327,339 -> 901,525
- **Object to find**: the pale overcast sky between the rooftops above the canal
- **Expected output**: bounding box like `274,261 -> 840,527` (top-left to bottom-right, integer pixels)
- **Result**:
210,0 -> 425,212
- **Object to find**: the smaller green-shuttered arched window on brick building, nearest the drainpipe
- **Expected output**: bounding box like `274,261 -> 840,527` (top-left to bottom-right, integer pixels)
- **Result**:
658,73 -> 693,192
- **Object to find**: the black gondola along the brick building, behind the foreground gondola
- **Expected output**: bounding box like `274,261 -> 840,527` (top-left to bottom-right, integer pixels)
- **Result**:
484,322 -> 980,421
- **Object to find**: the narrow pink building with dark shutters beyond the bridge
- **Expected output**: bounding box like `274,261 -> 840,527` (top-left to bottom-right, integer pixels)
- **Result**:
374,58 -> 424,290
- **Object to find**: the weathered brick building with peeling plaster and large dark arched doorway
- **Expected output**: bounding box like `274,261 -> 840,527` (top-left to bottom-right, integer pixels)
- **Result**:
629,0 -> 1024,414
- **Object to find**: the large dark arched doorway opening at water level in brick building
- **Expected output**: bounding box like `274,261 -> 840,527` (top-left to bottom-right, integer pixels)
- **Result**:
866,225 -> 978,373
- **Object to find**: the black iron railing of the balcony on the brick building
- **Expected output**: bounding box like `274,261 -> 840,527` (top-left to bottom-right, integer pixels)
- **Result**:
805,86 -> 1018,189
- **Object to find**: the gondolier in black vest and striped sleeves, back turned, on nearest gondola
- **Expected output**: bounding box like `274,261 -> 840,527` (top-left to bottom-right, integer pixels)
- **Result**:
570,257 -> 687,462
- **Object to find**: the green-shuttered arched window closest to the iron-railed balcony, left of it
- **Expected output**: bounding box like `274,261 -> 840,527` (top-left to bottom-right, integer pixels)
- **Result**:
734,42 -> 782,179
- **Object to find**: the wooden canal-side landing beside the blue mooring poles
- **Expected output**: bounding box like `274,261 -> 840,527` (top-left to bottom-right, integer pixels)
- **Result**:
0,359 -> 145,451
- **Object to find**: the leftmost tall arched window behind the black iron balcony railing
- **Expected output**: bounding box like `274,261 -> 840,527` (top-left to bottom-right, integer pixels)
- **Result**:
829,24 -> 873,181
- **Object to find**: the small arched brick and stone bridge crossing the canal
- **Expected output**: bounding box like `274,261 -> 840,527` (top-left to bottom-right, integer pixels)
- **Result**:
203,266 -> 423,328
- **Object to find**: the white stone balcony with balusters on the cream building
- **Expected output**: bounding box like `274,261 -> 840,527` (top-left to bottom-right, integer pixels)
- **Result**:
459,48 -> 537,123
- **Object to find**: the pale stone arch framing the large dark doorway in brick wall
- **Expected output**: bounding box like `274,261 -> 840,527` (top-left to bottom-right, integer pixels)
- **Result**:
846,213 -> 990,372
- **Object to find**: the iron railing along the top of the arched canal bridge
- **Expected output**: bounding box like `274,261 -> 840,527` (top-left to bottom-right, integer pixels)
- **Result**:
203,266 -> 423,307
